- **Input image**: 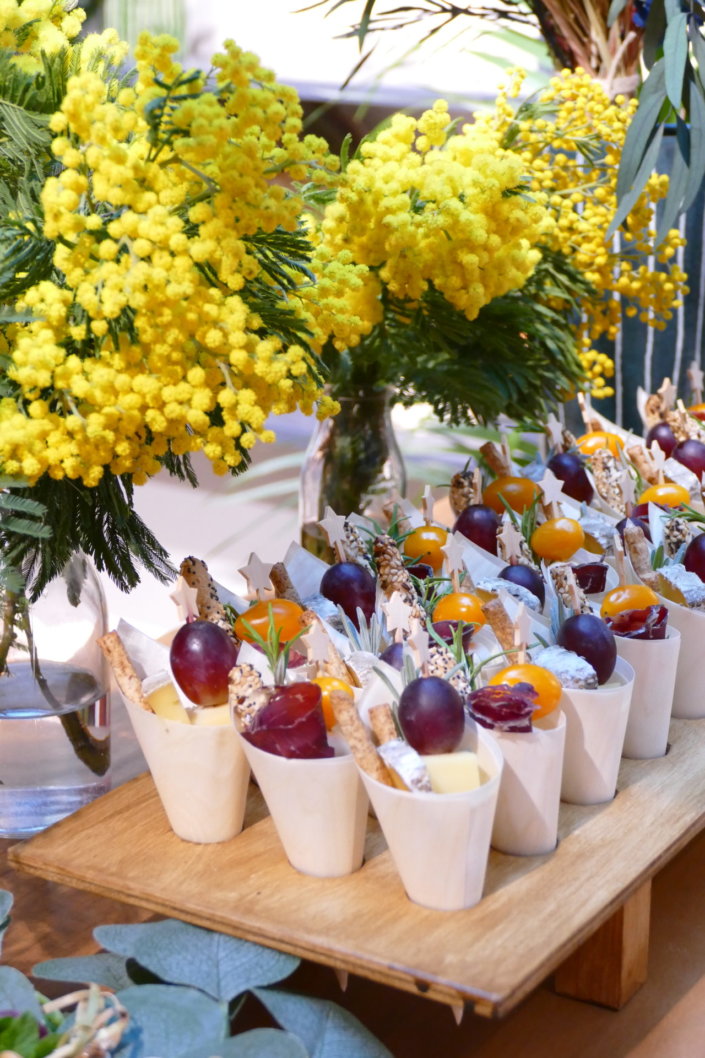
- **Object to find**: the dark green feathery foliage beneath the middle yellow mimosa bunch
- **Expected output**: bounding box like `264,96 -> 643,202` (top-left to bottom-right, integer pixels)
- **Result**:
326,250 -> 592,423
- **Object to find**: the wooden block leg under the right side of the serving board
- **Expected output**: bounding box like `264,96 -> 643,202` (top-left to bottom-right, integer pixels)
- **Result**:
554,881 -> 651,1010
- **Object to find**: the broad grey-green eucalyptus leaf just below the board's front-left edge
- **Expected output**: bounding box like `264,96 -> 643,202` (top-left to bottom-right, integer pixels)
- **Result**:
94,918 -> 300,1002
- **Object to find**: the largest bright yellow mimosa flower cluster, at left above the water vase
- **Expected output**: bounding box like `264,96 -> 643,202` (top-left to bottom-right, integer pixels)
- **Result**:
0,26 -> 357,486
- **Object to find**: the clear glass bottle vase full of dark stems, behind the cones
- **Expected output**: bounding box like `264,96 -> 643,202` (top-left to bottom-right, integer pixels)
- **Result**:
299,388 -> 406,561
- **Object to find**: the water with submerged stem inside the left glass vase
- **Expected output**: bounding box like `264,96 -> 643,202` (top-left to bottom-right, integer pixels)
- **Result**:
0,660 -> 110,838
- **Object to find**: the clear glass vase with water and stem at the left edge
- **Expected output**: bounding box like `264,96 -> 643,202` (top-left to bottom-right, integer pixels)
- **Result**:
0,554 -> 110,838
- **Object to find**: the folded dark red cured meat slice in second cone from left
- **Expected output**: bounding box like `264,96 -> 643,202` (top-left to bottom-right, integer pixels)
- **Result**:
243,682 -> 333,760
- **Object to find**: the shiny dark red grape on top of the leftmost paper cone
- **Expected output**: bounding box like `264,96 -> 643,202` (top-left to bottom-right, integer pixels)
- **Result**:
169,621 -> 238,706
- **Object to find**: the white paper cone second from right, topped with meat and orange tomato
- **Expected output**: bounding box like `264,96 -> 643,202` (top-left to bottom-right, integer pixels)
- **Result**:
615,627 -> 681,761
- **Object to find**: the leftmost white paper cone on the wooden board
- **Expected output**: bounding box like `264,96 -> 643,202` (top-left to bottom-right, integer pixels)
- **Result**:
125,699 -> 250,844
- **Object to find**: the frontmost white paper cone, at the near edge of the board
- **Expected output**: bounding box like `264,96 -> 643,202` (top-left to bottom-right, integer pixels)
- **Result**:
361,729 -> 503,911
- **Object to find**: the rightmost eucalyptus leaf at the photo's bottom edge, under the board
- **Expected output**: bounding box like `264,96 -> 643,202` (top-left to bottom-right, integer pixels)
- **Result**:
255,988 -> 394,1058
